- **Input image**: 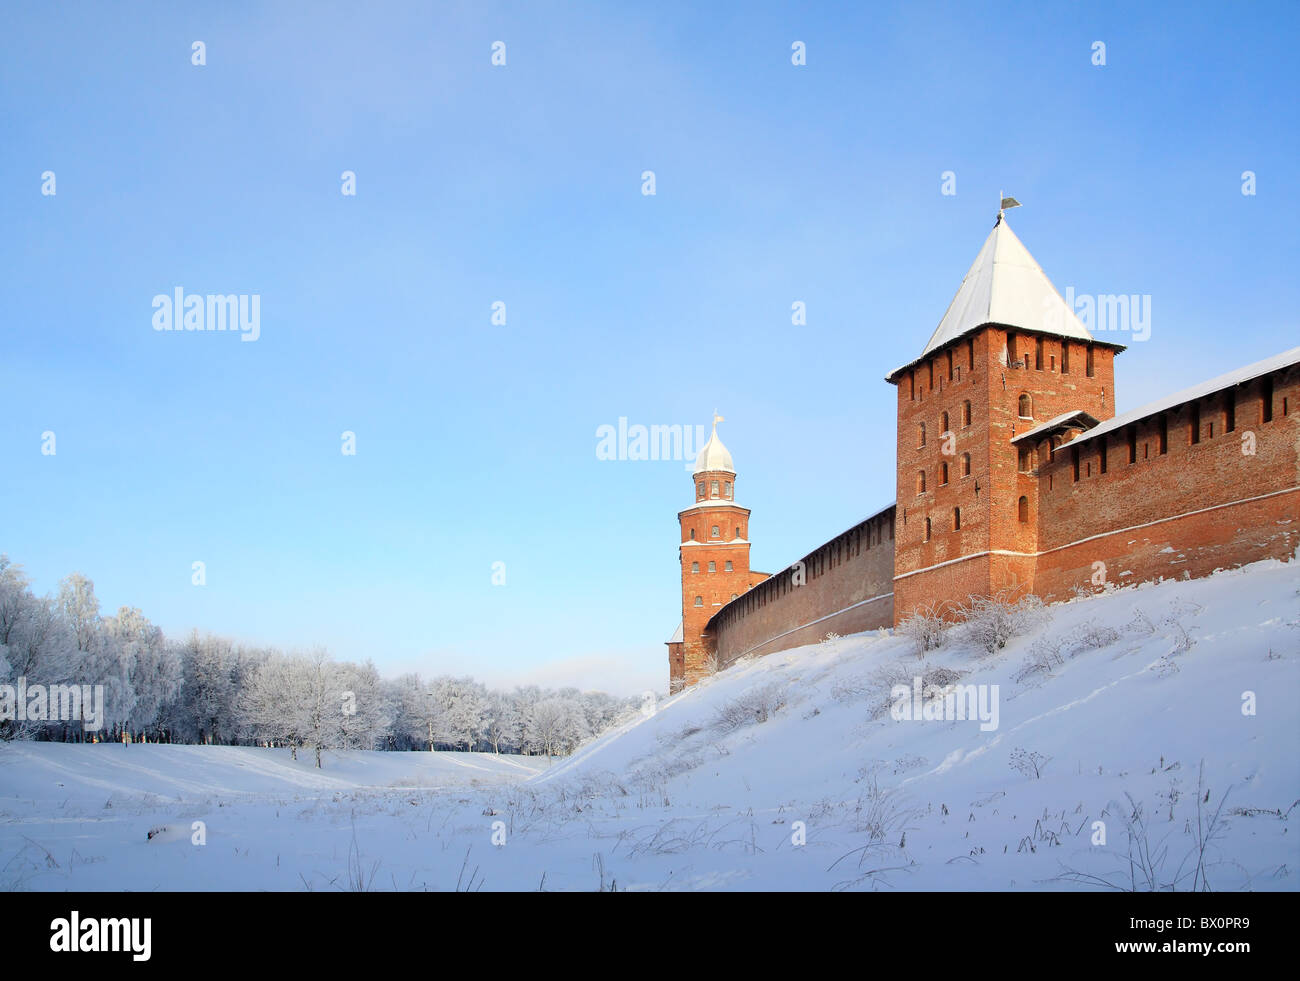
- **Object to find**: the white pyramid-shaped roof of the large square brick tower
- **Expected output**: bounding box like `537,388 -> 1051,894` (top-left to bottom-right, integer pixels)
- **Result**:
887,218 -> 1093,381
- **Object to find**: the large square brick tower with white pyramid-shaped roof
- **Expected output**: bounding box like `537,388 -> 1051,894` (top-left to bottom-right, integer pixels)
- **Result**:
885,212 -> 1123,622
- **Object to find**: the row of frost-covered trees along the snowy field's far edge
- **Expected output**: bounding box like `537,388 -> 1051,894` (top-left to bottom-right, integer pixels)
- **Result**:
0,555 -> 636,767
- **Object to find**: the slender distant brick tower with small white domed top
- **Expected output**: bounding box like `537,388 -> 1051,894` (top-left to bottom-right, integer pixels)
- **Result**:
668,414 -> 754,691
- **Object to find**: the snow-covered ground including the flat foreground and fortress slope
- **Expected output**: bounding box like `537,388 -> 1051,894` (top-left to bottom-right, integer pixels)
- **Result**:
0,561 -> 1300,890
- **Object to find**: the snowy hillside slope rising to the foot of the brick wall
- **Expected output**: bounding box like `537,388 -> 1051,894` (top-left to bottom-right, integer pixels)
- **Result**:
533,561 -> 1300,889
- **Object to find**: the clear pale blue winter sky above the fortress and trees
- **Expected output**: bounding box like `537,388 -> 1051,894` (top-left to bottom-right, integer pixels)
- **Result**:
0,3 -> 1300,694
